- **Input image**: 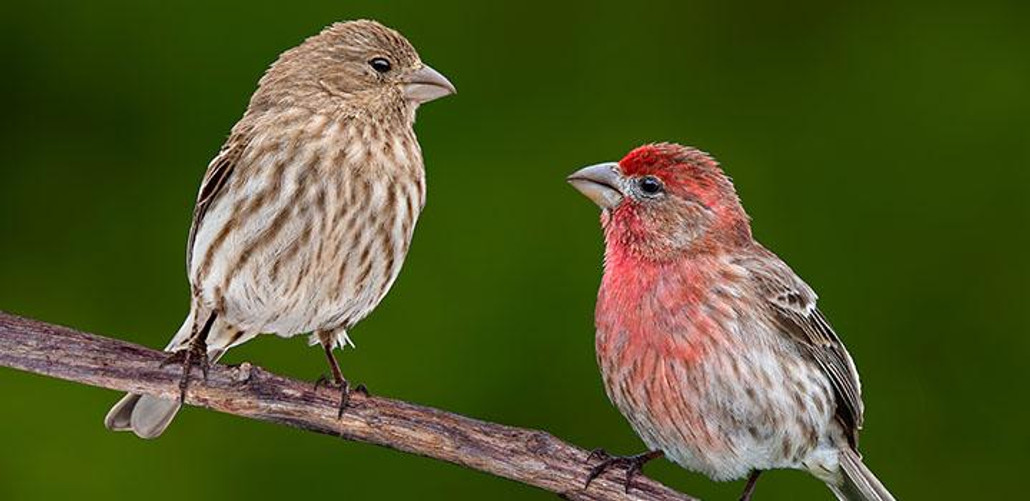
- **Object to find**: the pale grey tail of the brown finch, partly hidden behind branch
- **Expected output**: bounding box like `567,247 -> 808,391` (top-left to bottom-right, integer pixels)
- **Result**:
104,311 -> 235,438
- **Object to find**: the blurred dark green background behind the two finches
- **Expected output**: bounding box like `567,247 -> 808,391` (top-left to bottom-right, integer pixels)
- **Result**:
0,0 -> 1030,501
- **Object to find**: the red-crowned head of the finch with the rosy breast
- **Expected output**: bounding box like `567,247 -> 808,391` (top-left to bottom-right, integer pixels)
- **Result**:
569,143 -> 751,260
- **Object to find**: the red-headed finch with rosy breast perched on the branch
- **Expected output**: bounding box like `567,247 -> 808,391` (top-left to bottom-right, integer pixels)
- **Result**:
569,143 -> 894,501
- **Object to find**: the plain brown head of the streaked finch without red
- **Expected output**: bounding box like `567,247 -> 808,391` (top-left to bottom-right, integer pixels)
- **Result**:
251,20 -> 456,113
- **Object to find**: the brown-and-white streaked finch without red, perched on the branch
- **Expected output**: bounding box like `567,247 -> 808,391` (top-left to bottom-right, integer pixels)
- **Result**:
105,21 -> 454,438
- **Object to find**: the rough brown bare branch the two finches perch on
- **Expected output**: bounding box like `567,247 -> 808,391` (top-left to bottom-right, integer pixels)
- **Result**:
0,311 -> 693,501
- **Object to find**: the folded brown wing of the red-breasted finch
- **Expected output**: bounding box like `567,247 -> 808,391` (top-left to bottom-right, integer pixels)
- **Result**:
741,248 -> 863,449
